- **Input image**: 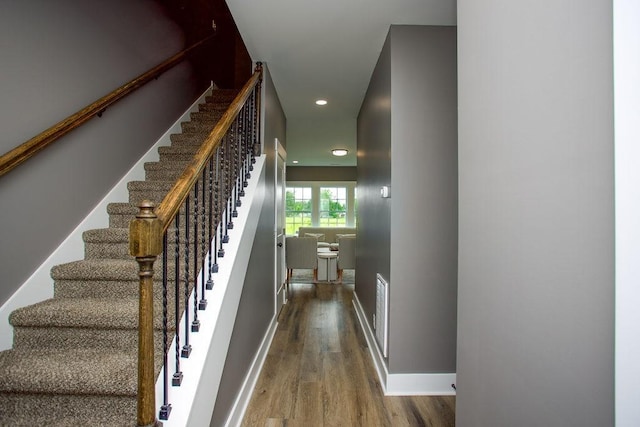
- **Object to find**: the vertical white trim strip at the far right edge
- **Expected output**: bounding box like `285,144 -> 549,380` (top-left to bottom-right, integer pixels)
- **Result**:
613,0 -> 640,427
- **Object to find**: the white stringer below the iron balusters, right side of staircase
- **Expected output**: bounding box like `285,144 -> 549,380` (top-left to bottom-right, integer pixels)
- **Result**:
156,154 -> 267,427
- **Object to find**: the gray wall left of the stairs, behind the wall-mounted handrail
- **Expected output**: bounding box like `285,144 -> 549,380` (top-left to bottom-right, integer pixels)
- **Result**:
0,0 -> 198,304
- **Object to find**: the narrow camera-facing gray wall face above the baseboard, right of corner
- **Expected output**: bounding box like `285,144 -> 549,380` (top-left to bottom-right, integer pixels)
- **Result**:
389,26 -> 458,373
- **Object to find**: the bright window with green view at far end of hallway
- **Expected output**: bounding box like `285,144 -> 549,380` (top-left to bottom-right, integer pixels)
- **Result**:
285,181 -> 357,235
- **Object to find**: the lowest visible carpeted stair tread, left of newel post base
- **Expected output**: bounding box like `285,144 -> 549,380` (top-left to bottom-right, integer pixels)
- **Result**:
0,349 -> 137,396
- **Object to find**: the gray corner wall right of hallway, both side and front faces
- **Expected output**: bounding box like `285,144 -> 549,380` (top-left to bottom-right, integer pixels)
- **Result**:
356,26 -> 458,373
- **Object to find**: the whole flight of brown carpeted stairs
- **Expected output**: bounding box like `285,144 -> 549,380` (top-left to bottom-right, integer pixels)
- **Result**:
0,90 -> 237,426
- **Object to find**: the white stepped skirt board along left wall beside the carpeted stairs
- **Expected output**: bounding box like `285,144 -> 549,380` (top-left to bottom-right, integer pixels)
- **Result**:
0,87 -> 212,350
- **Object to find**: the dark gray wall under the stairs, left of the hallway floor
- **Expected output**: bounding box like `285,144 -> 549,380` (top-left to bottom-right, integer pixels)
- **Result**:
210,66 -> 286,426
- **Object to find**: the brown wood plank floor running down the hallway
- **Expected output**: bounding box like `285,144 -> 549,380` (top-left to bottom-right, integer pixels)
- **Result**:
242,284 -> 455,427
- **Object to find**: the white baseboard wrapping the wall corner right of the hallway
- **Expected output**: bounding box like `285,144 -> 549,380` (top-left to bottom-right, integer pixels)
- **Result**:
353,291 -> 456,396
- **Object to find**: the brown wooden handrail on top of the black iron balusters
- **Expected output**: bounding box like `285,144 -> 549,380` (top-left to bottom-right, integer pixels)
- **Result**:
155,63 -> 262,233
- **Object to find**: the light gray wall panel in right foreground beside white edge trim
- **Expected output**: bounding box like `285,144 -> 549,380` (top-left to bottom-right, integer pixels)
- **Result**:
456,0 -> 614,427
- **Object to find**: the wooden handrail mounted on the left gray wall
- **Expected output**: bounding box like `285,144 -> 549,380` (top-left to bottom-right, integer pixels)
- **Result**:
0,35 -> 213,176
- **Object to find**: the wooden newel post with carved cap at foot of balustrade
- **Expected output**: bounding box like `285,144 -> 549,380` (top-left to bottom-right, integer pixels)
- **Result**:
129,200 -> 162,426
